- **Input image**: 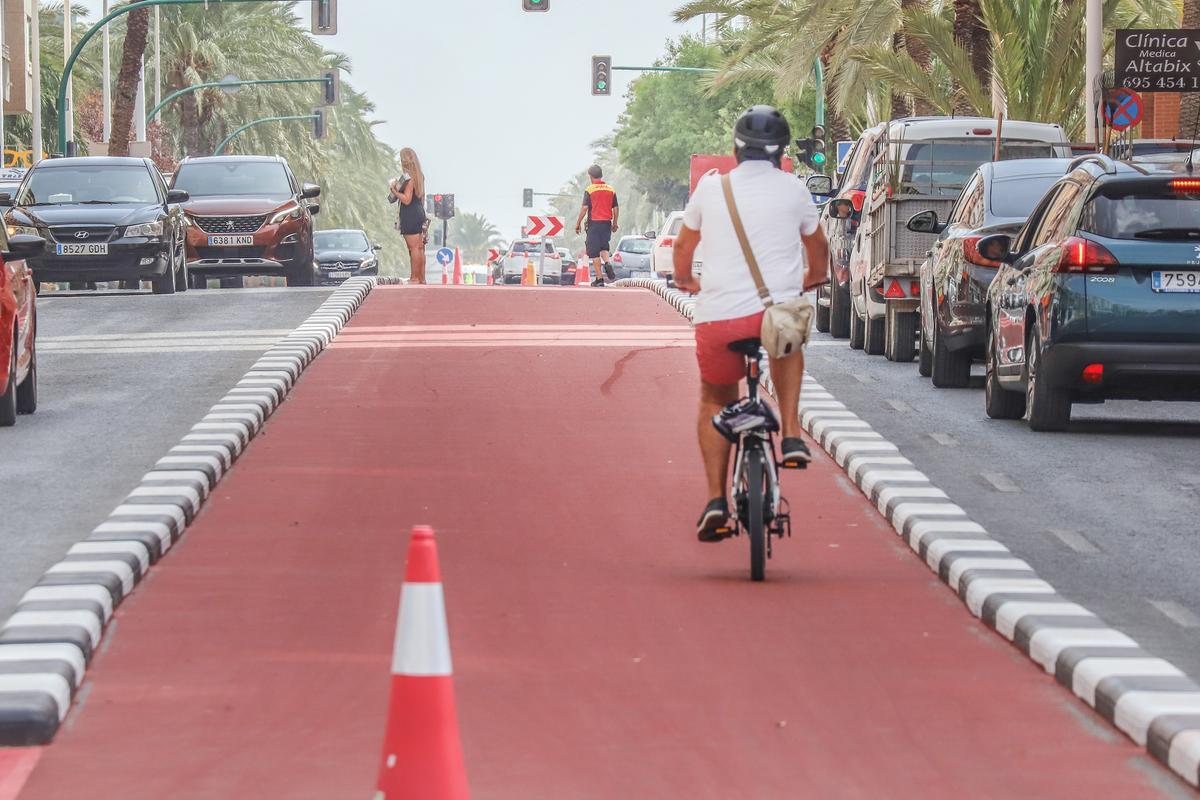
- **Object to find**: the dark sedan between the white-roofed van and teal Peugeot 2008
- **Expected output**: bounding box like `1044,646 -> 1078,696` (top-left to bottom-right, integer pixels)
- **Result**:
907,158 -> 1072,387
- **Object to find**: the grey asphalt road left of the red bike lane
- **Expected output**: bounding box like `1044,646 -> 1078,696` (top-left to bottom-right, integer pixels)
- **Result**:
0,289 -> 330,620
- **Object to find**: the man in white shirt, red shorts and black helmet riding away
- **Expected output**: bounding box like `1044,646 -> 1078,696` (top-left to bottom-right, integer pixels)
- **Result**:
674,106 -> 829,542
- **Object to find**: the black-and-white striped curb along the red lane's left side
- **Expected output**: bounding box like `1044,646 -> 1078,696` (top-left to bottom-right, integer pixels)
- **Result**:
0,278 -> 379,746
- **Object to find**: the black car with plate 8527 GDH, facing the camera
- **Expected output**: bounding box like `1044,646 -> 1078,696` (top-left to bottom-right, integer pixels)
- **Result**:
0,157 -> 187,294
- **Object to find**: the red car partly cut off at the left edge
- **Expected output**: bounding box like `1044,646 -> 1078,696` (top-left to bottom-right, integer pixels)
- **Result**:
0,229 -> 46,427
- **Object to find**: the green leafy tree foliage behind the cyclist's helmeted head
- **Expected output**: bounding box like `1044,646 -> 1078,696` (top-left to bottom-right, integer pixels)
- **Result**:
614,36 -> 814,216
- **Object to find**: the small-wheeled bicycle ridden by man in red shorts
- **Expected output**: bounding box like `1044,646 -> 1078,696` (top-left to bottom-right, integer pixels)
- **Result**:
713,338 -> 799,581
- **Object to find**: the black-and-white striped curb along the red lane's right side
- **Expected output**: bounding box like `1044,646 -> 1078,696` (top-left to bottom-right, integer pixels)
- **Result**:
617,279 -> 1200,786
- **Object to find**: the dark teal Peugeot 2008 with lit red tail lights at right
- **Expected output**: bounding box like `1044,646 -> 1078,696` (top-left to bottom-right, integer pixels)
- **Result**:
979,155 -> 1200,431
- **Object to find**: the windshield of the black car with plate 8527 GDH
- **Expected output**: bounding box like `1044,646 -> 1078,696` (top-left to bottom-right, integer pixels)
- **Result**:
17,164 -> 158,205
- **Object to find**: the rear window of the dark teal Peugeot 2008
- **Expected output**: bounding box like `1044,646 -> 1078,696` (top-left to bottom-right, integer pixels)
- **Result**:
1079,194 -> 1200,241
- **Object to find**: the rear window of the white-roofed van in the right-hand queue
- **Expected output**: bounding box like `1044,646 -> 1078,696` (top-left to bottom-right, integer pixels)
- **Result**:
900,139 -> 1055,197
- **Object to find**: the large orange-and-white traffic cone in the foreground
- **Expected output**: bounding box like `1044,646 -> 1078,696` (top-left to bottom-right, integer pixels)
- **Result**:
376,525 -> 469,800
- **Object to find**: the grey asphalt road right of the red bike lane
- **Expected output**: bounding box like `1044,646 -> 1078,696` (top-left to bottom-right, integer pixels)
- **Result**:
808,333 -> 1200,678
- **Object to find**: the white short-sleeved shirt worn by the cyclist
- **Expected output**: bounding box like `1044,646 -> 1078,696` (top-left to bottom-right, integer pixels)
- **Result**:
683,161 -> 818,323
